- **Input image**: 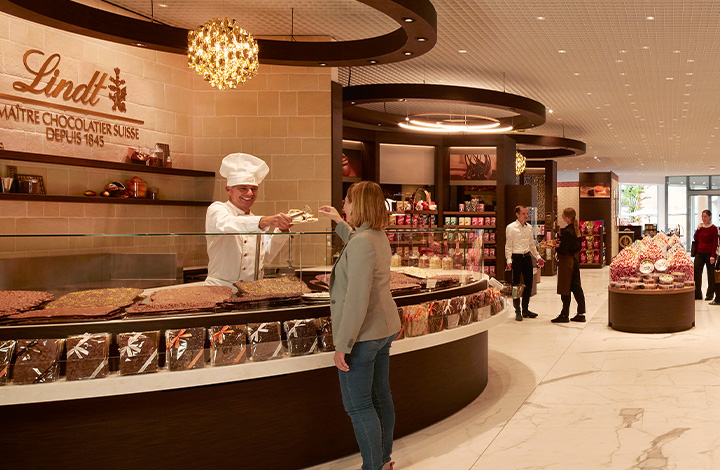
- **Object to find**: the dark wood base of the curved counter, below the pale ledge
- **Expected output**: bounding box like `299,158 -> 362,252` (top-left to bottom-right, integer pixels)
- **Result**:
0,330 -> 488,469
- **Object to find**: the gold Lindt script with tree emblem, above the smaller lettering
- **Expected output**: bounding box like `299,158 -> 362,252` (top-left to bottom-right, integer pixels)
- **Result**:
13,49 -> 127,113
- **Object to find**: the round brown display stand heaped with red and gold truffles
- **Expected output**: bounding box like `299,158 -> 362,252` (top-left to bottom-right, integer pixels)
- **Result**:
608,233 -> 695,333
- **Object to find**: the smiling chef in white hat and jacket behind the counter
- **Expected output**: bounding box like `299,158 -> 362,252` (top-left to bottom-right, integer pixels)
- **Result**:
205,153 -> 292,290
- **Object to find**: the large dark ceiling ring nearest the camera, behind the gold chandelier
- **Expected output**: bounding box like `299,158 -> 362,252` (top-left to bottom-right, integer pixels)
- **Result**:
0,0 -> 437,67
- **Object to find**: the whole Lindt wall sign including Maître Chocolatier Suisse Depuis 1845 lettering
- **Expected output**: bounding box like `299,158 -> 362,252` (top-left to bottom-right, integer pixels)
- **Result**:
0,49 -> 144,147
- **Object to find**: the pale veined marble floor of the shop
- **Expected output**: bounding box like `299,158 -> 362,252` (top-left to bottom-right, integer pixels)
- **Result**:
313,268 -> 720,470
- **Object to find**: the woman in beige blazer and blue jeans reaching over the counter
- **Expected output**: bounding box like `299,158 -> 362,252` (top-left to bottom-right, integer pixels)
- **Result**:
319,181 -> 400,470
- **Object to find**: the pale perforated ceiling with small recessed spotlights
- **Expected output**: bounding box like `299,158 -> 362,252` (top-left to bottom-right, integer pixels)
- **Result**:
102,0 -> 720,177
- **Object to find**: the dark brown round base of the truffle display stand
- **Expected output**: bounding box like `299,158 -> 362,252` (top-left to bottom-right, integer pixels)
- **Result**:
608,287 -> 695,333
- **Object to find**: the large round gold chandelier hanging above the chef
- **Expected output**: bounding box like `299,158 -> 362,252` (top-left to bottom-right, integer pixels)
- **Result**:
188,18 -> 258,90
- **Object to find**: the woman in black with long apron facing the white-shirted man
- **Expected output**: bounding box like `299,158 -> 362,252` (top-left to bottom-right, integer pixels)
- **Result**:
550,207 -> 585,323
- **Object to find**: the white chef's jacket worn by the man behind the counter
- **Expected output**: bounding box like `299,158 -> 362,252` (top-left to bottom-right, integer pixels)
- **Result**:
205,201 -> 287,290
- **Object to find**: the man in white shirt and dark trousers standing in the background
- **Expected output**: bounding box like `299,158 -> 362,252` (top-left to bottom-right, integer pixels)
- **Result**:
505,206 -> 545,321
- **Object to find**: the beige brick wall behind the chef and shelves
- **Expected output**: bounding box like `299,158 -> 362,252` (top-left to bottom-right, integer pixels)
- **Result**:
0,13 -> 331,265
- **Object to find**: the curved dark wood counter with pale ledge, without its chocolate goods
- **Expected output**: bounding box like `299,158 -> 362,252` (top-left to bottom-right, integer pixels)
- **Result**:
0,282 -> 510,469
